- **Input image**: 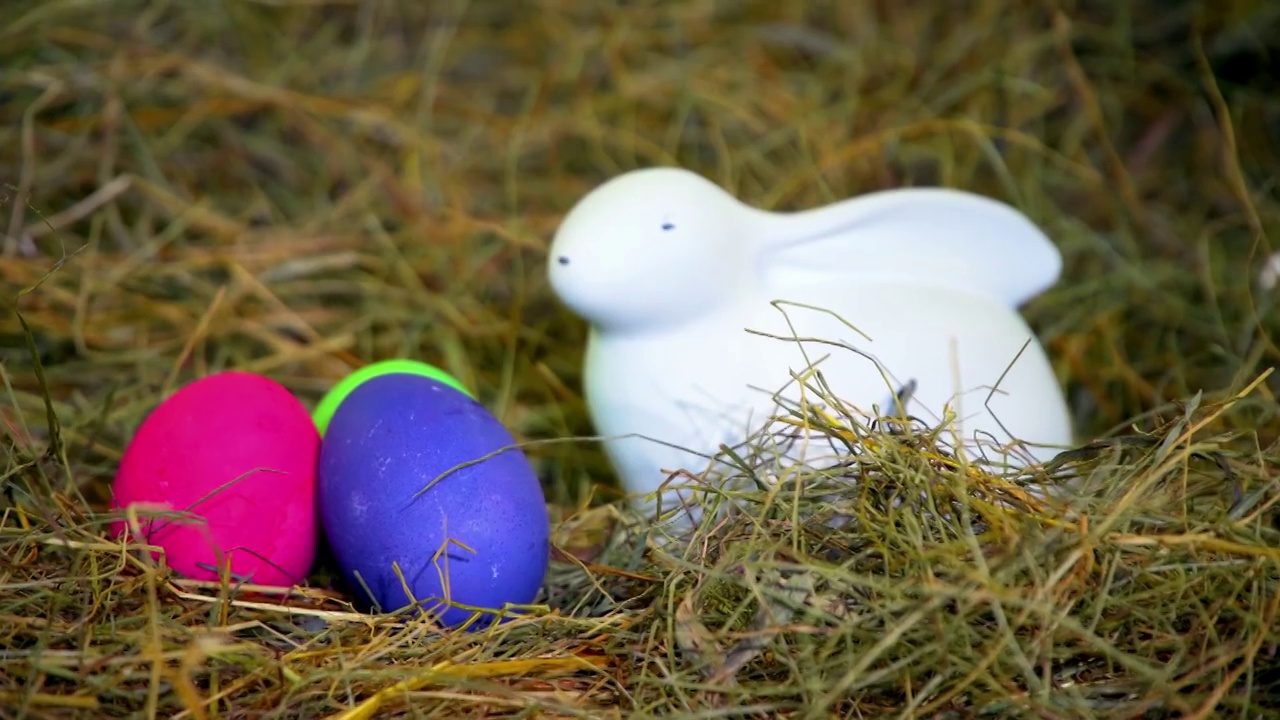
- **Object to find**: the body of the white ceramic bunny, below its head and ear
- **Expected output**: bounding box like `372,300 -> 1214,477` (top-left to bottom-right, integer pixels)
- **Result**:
584,271 -> 1071,507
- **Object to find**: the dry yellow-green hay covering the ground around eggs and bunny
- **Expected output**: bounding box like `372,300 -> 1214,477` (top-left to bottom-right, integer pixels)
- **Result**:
0,0 -> 1280,719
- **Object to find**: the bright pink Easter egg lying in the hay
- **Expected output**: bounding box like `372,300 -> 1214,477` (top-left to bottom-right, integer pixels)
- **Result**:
111,372 -> 320,587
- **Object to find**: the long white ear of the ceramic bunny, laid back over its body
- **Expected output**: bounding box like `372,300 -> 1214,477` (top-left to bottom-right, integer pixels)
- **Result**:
758,188 -> 1062,306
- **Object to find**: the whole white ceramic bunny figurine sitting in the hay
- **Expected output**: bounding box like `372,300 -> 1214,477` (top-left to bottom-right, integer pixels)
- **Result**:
548,168 -> 1073,517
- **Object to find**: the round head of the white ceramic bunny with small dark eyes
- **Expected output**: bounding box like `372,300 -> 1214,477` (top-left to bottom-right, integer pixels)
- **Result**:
548,168 -> 756,332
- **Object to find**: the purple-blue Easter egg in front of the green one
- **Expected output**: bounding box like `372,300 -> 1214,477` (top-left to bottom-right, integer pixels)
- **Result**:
317,374 -> 550,629
